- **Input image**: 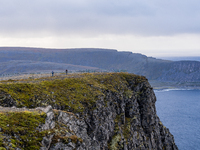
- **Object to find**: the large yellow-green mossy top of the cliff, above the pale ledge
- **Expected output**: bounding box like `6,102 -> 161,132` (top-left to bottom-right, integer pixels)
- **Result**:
0,73 -> 145,112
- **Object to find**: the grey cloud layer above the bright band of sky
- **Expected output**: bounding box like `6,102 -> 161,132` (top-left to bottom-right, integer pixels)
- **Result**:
0,0 -> 200,35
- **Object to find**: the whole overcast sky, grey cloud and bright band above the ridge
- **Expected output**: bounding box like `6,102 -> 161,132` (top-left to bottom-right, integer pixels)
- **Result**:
0,0 -> 200,56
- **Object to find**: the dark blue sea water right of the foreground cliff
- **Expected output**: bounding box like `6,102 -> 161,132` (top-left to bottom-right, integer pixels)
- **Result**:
154,90 -> 200,150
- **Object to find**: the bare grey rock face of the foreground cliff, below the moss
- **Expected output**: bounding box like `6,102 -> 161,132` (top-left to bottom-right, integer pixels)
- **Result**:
39,83 -> 178,150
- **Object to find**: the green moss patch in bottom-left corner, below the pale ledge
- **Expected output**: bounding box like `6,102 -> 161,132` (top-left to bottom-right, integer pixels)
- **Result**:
0,111 -> 46,150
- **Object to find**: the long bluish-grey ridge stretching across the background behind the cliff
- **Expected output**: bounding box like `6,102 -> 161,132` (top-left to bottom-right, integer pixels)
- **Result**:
0,47 -> 200,82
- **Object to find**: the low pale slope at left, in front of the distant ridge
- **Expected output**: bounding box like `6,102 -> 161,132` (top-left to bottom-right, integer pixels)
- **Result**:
0,60 -> 99,75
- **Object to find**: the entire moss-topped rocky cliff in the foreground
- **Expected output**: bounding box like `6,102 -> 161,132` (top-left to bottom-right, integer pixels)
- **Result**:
0,73 -> 178,150
